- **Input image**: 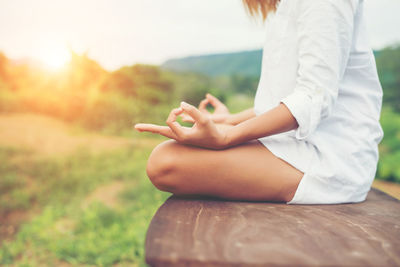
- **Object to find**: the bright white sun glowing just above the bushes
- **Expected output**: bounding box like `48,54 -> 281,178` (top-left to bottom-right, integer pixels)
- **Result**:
37,44 -> 71,70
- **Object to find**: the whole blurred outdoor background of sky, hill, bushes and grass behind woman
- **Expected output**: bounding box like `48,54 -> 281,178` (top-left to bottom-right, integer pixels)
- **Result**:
0,0 -> 400,266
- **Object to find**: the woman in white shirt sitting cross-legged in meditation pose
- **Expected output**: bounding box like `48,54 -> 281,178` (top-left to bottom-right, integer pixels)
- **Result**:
135,0 -> 383,204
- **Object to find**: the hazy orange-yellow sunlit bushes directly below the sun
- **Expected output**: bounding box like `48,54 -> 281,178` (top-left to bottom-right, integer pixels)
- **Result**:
0,54 -> 177,133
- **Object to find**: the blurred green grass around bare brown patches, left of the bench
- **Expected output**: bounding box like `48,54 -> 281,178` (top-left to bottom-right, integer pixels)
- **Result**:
0,143 -> 169,266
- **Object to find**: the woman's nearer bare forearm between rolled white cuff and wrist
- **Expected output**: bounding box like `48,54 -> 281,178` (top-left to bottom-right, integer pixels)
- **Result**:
225,103 -> 298,147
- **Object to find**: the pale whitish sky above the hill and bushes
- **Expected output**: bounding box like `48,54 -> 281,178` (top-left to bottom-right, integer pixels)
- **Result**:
0,0 -> 400,70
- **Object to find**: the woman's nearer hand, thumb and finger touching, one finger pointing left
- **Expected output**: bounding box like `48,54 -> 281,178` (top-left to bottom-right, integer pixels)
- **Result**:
135,102 -> 226,149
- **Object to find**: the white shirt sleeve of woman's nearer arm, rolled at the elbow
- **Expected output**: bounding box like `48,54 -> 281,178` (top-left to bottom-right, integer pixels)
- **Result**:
281,0 -> 356,139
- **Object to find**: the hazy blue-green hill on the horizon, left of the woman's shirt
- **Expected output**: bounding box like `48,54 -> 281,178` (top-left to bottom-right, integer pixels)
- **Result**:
161,50 -> 262,77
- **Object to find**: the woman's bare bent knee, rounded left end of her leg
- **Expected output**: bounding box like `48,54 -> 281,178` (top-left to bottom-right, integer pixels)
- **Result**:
146,141 -> 177,192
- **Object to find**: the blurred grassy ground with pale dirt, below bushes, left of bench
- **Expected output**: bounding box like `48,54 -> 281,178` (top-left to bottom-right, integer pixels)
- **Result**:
0,114 -> 168,266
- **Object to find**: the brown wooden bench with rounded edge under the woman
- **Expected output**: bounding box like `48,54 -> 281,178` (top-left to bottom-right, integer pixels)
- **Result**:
146,189 -> 400,266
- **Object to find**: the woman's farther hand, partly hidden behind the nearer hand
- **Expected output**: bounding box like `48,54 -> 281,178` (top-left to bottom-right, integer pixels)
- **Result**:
180,94 -> 230,123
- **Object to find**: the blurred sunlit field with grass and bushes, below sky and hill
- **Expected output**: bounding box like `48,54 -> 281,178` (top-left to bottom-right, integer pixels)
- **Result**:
0,47 -> 400,266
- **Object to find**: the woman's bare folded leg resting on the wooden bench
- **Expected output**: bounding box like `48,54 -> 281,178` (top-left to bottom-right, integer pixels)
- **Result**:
147,141 -> 303,202
